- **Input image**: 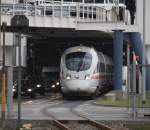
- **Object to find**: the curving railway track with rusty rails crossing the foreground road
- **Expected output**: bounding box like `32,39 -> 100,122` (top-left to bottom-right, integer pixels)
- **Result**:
43,101 -> 120,130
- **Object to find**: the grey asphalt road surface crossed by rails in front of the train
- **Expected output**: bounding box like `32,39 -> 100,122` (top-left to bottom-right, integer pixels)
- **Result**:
0,95 -> 150,121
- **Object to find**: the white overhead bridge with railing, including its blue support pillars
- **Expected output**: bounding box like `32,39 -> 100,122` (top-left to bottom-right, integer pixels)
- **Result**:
1,0 -> 149,90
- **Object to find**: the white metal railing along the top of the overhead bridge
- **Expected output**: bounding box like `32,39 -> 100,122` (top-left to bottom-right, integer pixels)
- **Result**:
1,2 -> 125,22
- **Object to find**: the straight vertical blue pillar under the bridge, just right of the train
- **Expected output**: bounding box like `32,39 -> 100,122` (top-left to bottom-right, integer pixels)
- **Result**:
113,30 -> 123,90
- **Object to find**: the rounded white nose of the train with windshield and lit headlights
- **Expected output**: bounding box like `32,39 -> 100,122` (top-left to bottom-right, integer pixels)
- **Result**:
60,47 -> 97,97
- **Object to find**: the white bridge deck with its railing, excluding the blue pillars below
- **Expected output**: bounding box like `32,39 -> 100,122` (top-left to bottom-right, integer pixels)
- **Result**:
1,3 -> 138,32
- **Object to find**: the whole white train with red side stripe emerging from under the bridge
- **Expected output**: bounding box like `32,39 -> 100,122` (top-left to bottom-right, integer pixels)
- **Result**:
60,46 -> 113,97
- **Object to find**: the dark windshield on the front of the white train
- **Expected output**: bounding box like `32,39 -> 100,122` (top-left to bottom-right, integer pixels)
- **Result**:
66,52 -> 92,71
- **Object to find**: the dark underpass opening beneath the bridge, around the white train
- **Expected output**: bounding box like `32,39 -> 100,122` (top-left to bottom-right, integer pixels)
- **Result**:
26,34 -> 113,92
